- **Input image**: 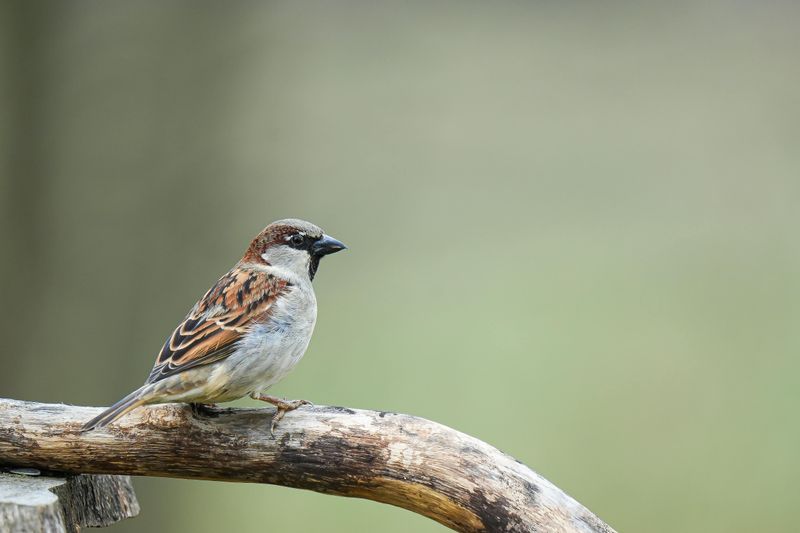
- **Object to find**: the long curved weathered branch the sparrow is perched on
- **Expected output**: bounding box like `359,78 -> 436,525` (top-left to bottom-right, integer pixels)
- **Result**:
0,399 -> 613,533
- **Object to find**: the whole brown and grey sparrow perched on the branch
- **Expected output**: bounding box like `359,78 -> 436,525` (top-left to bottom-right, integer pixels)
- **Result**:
82,219 -> 346,431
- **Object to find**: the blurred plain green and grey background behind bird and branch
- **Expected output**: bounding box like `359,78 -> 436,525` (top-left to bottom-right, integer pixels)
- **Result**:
0,1 -> 800,533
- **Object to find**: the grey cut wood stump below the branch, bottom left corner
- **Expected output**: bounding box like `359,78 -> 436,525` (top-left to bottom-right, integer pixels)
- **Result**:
0,473 -> 139,533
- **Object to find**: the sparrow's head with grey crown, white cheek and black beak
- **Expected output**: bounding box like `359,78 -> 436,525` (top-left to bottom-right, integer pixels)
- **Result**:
242,218 -> 347,280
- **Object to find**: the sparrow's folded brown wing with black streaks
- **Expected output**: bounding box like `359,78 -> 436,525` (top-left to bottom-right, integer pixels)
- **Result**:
147,267 -> 289,383
